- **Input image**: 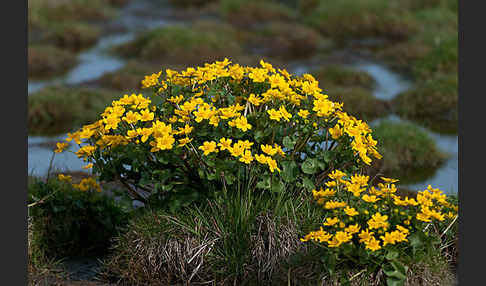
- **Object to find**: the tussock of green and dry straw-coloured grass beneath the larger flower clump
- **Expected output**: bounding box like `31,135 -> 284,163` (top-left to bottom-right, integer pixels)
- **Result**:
104,187 -> 320,285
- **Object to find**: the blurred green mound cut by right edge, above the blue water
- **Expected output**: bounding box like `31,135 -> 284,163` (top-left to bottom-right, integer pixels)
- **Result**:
392,74 -> 459,133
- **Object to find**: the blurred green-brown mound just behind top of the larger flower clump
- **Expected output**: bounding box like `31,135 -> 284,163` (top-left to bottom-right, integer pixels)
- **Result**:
115,23 -> 241,65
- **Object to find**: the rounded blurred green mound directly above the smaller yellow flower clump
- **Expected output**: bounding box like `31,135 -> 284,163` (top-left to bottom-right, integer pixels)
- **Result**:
373,120 -> 447,183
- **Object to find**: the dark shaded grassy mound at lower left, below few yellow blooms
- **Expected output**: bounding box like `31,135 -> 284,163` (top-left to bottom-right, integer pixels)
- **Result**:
28,178 -> 128,261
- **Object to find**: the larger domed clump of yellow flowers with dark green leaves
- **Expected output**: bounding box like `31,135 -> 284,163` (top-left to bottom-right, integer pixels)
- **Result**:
56,59 -> 381,208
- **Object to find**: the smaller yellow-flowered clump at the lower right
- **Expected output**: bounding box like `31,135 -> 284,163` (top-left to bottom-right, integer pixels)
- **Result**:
301,170 -> 458,285
